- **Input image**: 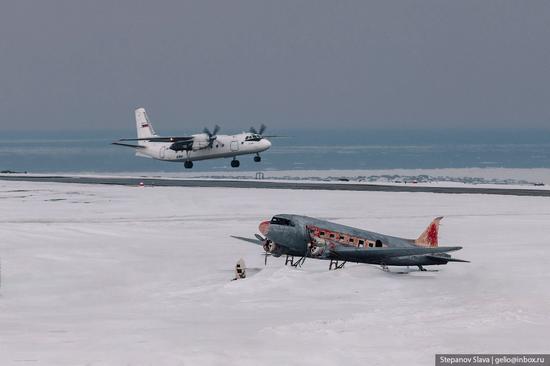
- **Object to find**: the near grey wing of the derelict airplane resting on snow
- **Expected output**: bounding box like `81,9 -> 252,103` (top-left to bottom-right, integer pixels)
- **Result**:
331,247 -> 462,262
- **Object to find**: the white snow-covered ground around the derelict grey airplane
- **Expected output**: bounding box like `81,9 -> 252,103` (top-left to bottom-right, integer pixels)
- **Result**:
0,181 -> 550,365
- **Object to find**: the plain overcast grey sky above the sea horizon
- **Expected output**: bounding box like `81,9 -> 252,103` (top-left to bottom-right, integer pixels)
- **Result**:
0,0 -> 550,132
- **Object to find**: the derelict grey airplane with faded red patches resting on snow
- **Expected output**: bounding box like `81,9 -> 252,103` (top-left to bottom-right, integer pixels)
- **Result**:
232,214 -> 468,271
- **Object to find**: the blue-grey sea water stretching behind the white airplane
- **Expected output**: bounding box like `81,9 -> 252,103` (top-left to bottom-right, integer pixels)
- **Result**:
0,130 -> 550,173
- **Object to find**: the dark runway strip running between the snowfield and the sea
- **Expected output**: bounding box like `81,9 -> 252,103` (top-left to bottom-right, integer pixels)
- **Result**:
0,175 -> 550,197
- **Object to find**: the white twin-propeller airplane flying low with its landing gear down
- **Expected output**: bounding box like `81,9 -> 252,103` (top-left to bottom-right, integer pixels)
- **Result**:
113,108 -> 273,169
